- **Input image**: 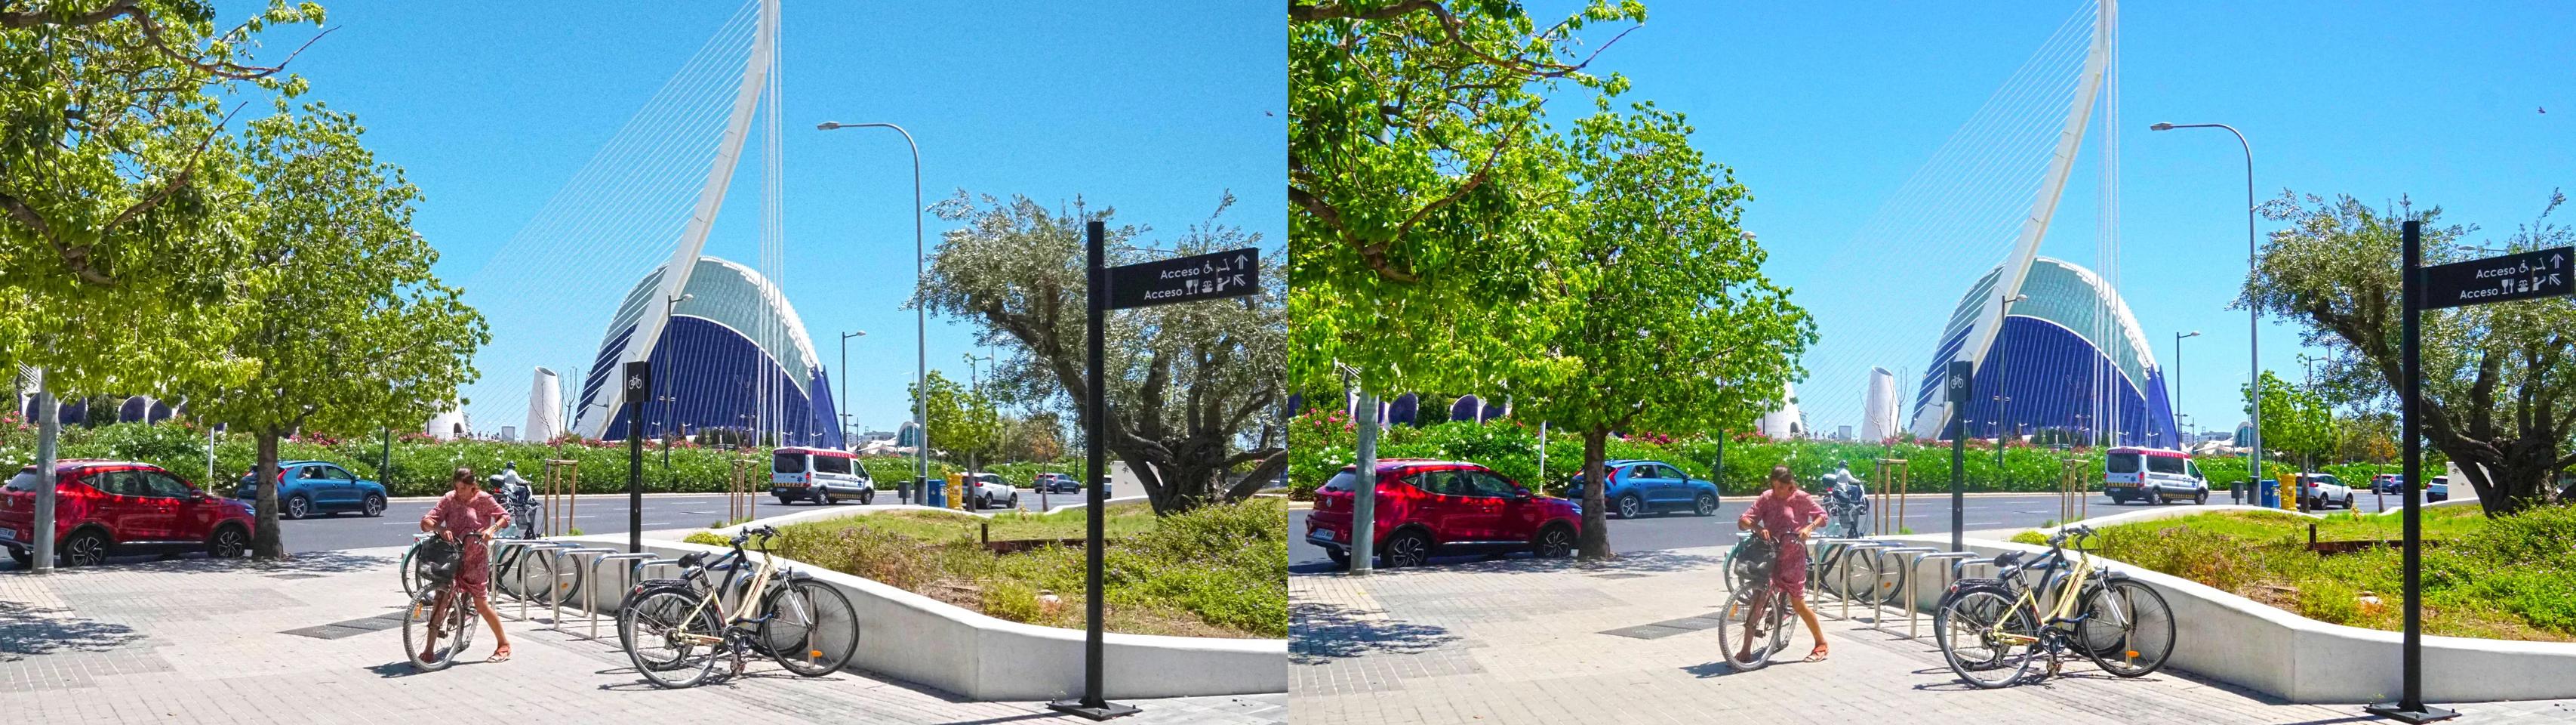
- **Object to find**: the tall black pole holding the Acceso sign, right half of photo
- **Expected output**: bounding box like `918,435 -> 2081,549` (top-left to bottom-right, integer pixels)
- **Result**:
2362,219 -> 2460,723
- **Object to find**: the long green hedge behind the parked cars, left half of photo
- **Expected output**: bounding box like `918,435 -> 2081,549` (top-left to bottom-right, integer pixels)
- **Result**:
0,415 -> 1082,495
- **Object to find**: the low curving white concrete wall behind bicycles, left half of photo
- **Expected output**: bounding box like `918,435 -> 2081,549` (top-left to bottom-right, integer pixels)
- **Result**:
567,495 -> 1288,699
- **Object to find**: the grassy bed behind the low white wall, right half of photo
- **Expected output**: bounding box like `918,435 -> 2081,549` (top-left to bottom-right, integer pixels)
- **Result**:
2012,506 -> 2576,643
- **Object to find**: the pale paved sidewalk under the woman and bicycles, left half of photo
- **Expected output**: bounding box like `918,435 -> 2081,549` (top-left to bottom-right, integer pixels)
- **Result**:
0,550 -> 1288,725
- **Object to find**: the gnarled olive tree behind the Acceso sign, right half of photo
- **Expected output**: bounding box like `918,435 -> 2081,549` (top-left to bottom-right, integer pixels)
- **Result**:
2239,191 -> 2576,516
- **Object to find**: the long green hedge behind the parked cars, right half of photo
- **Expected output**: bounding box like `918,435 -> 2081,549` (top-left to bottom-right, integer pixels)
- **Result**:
1288,410 -> 2396,498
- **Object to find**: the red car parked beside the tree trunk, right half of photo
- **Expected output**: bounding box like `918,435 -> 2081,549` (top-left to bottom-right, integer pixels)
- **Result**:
1306,459 -> 1584,568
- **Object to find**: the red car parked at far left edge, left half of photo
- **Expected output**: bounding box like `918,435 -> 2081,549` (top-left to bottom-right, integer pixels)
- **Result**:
0,459 -> 257,568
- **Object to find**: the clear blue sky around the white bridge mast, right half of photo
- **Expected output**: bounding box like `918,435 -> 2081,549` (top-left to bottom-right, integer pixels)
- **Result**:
1533,0 -> 2576,431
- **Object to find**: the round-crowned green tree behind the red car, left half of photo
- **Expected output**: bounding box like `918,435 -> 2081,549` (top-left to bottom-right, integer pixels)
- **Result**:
186,100 -> 489,557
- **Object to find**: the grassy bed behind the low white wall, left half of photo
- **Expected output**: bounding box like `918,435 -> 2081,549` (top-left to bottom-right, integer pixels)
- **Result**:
688,498 -> 1288,637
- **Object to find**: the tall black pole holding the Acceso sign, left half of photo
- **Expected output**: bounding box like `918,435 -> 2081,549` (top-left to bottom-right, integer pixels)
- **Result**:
1046,222 -> 1136,720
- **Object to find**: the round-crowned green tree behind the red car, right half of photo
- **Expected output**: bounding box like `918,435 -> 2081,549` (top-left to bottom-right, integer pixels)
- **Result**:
1530,103 -> 1816,557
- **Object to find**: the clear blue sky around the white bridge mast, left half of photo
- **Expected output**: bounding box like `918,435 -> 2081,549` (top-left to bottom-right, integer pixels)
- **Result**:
245,0 -> 1285,428
